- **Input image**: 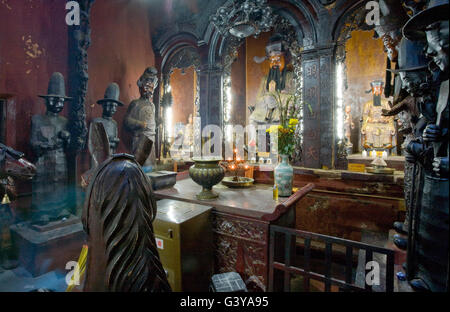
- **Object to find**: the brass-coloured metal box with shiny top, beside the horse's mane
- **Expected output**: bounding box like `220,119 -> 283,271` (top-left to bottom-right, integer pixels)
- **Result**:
153,199 -> 214,292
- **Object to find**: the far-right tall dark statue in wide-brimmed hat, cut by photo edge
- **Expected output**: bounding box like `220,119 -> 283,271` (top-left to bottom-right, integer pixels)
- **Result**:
403,0 -> 450,291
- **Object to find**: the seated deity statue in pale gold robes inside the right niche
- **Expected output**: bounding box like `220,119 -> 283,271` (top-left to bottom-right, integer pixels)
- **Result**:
361,81 -> 396,150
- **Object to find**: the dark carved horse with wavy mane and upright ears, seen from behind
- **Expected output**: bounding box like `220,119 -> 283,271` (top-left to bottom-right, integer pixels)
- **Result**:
82,124 -> 171,292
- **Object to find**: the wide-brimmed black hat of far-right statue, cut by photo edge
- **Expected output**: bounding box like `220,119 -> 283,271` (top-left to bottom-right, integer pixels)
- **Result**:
403,0 -> 448,40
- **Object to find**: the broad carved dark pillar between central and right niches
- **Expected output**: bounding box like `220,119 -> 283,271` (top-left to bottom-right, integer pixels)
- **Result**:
302,46 -> 335,169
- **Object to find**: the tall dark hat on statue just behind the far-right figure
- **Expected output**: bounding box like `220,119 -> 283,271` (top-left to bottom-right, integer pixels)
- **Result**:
387,38 -> 428,74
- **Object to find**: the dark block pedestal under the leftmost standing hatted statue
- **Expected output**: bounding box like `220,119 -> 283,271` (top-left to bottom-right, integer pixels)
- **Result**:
10,216 -> 85,277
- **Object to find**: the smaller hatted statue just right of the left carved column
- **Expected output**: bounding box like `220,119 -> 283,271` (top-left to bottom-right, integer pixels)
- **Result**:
89,82 -> 123,154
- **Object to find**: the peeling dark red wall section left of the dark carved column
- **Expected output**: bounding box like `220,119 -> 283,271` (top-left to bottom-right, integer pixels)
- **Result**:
0,0 -> 68,159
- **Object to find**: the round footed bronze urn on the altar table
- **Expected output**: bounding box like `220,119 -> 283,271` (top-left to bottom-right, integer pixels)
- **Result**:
189,157 -> 225,200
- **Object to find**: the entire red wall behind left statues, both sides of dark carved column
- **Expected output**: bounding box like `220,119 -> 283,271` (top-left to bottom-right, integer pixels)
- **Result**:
0,0 -> 155,183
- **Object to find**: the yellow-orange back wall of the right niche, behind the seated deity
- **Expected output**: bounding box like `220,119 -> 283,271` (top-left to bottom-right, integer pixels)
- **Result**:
344,30 -> 387,153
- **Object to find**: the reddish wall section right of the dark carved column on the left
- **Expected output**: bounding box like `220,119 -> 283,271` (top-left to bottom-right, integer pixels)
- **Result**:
78,0 -> 155,173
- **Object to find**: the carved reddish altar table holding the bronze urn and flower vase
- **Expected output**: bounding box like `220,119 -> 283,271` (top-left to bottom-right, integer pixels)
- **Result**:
154,178 -> 314,291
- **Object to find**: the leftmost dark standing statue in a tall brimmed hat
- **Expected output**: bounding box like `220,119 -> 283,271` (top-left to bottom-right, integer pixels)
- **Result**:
30,73 -> 71,224
